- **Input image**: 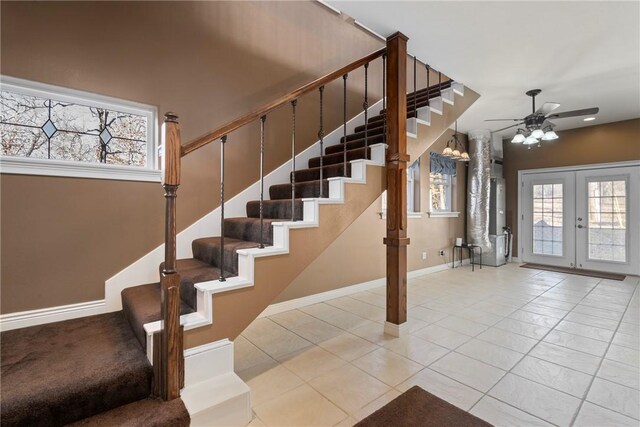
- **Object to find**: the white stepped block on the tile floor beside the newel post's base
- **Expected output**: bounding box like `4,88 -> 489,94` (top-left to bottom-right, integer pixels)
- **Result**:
181,339 -> 252,426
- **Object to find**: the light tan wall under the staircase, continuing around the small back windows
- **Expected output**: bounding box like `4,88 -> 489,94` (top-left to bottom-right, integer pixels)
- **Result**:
276,130 -> 466,302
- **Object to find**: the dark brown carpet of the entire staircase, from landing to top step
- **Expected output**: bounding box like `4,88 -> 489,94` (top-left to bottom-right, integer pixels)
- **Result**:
0,83 -> 448,426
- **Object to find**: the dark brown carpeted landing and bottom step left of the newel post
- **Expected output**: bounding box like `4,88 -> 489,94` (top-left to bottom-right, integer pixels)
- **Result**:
0,311 -> 189,426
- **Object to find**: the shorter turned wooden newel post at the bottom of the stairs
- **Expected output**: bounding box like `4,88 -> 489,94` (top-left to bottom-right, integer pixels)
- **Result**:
154,113 -> 184,400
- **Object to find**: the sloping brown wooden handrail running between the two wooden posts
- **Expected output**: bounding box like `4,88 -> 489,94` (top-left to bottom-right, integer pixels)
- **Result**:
180,48 -> 386,157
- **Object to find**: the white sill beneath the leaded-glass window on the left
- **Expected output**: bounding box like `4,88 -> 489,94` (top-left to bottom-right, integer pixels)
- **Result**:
0,156 -> 161,182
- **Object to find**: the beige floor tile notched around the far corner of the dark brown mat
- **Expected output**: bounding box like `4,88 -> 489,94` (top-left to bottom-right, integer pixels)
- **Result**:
396,368 -> 482,411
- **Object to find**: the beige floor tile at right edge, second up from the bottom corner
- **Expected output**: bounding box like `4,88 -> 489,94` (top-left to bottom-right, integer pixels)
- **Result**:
587,378 -> 640,420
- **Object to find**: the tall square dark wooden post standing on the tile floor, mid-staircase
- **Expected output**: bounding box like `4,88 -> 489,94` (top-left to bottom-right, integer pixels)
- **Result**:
383,32 -> 409,336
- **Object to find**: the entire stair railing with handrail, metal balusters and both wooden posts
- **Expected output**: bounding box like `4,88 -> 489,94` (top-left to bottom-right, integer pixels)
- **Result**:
153,33 -> 452,400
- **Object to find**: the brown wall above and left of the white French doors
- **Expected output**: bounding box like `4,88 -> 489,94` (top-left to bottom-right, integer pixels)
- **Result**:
504,119 -> 640,256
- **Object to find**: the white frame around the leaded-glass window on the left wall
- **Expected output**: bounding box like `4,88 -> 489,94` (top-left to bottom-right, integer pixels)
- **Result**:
0,75 -> 161,182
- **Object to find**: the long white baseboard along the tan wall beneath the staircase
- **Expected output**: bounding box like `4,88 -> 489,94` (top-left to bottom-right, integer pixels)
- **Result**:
258,258 -> 469,317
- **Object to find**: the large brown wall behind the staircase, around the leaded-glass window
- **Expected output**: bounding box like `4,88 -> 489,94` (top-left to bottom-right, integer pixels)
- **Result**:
0,2 -> 383,313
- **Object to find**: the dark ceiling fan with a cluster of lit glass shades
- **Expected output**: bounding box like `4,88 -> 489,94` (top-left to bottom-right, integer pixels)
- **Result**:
485,89 -> 600,148
